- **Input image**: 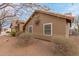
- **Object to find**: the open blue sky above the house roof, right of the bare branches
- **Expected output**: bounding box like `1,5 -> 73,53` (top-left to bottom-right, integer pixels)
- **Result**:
22,3 -> 79,19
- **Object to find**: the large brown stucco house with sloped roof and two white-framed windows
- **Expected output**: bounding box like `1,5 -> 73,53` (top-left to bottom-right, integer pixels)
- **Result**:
24,10 -> 74,37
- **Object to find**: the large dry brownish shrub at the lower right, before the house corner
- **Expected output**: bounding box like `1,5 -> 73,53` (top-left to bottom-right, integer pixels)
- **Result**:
53,37 -> 79,56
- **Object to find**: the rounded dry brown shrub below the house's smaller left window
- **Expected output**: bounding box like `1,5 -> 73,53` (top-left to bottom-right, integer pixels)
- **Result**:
16,32 -> 33,47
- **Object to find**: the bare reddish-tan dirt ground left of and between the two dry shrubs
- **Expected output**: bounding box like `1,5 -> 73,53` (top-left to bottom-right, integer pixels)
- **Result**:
0,36 -> 53,56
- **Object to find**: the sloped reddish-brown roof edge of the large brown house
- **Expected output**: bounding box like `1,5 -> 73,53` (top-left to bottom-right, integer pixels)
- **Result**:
24,10 -> 74,30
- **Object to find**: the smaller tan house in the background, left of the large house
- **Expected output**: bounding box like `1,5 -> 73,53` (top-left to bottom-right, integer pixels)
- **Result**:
10,20 -> 25,32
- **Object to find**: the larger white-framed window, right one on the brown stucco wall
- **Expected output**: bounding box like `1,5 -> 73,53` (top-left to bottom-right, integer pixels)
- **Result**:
43,23 -> 52,36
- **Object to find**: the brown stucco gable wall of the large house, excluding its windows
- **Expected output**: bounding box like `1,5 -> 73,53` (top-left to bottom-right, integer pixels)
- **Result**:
25,13 -> 72,37
